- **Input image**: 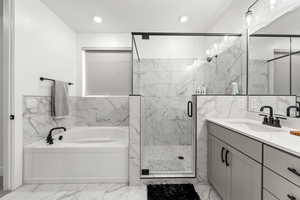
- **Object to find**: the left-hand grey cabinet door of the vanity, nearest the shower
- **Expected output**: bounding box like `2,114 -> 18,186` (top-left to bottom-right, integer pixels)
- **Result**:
208,136 -> 230,200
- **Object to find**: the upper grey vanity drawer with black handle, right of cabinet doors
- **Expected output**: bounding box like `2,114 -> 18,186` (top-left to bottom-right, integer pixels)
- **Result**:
264,145 -> 300,187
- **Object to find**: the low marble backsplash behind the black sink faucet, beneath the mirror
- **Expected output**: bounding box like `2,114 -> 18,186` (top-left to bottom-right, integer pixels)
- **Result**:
248,96 -> 296,116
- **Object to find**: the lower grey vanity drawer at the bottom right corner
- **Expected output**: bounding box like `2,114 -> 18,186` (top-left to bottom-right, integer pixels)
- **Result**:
264,167 -> 300,200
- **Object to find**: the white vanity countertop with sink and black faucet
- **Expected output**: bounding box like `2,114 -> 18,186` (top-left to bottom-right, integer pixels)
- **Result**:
207,118 -> 300,156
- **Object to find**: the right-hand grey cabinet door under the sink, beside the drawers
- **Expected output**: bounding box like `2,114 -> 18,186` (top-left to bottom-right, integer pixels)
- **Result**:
228,148 -> 262,200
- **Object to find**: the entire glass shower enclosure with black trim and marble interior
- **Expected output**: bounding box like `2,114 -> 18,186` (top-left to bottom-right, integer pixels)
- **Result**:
132,33 -> 246,178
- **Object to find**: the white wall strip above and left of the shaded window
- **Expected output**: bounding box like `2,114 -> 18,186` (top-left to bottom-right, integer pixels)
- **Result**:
76,33 -> 131,96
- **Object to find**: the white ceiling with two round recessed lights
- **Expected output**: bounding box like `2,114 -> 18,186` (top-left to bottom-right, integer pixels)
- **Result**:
41,0 -> 232,33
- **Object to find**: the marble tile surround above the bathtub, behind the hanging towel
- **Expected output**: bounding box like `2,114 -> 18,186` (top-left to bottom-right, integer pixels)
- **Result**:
23,96 -> 129,145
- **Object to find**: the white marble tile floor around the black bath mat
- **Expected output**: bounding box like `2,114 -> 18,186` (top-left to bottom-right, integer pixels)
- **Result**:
0,183 -> 221,200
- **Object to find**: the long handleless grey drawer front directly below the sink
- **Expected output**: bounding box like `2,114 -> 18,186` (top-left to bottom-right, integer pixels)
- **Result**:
207,122 -> 262,163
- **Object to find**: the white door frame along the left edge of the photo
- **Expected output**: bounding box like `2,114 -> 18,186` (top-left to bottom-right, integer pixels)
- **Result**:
1,0 -> 14,191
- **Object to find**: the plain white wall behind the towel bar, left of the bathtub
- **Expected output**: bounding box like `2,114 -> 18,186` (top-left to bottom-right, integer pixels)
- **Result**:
13,0 -> 77,186
